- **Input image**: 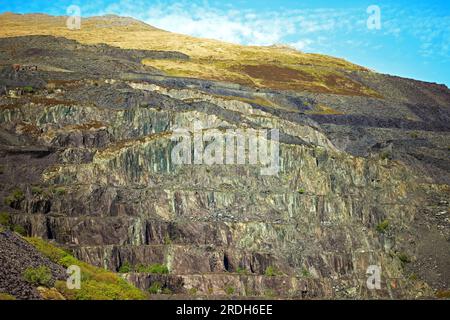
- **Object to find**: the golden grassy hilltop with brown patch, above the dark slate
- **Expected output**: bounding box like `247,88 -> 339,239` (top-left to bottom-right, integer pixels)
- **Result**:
0,14 -> 376,96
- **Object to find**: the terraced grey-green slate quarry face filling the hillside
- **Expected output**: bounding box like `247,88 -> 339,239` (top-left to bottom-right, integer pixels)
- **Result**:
0,31 -> 450,299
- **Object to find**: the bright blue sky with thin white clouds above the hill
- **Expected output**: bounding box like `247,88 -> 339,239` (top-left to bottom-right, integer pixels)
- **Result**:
0,0 -> 450,87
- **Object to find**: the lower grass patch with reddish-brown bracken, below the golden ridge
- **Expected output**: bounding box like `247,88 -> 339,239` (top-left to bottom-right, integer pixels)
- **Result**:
142,58 -> 379,97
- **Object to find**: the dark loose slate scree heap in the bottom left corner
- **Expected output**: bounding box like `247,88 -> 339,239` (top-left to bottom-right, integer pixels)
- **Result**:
0,231 -> 67,299
